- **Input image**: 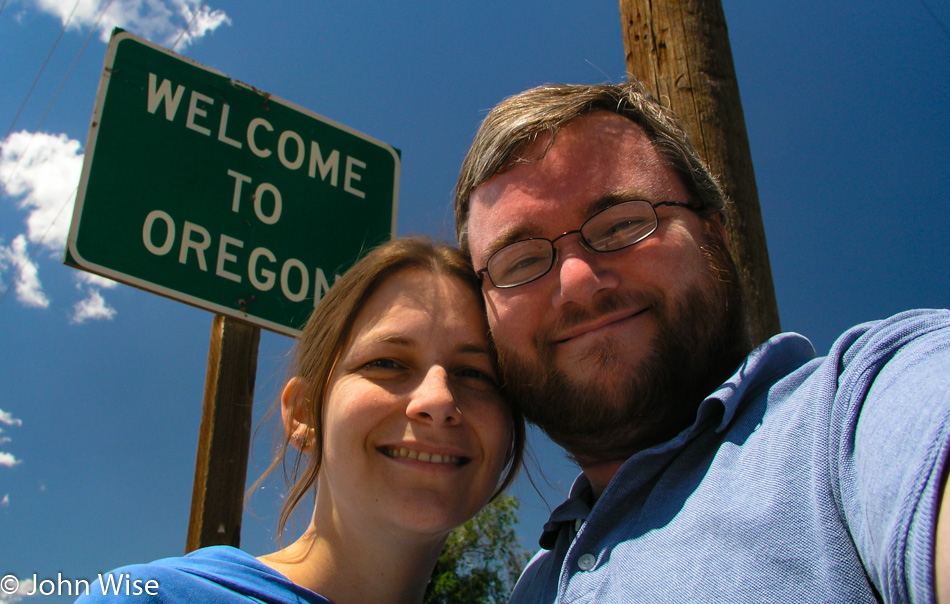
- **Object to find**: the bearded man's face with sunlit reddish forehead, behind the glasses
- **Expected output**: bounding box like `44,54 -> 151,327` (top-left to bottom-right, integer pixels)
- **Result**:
468,112 -> 744,464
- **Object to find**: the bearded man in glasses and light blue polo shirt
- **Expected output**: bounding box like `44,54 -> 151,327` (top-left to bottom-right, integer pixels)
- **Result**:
456,82 -> 950,603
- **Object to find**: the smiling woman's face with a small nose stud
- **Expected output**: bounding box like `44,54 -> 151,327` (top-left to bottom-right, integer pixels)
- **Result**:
317,268 -> 512,533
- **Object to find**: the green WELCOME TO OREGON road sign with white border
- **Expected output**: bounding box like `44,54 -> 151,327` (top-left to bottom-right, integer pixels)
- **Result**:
65,30 -> 399,335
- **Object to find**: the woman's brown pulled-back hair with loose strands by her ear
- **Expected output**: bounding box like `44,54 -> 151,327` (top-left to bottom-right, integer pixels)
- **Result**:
251,238 -> 525,540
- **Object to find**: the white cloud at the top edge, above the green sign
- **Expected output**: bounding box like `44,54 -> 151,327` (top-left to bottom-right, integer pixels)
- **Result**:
32,0 -> 231,50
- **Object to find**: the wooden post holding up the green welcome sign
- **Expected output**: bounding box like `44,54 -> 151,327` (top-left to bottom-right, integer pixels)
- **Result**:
185,315 -> 261,553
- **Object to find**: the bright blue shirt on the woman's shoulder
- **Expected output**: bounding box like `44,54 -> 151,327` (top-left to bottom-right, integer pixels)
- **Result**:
77,546 -> 329,604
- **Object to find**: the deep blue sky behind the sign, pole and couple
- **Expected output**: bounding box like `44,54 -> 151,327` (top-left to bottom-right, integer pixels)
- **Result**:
0,0 -> 950,604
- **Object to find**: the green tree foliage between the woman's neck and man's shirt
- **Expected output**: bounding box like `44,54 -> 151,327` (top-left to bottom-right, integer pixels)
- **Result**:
424,493 -> 530,604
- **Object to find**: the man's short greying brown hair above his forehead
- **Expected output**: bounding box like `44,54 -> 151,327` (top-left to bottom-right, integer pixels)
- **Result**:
455,80 -> 725,254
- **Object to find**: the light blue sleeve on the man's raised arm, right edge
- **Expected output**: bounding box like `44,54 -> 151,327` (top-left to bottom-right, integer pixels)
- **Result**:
829,310 -> 950,602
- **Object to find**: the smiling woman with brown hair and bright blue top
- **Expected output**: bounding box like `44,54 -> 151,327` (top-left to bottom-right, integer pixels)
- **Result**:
80,239 -> 524,604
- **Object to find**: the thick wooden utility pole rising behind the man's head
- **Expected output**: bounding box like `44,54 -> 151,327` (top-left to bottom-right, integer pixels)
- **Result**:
620,0 -> 780,344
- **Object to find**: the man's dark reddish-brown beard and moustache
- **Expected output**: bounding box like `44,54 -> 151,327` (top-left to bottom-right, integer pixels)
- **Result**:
499,229 -> 751,466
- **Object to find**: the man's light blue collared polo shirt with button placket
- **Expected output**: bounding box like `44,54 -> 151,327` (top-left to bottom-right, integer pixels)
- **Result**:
511,310 -> 950,604
